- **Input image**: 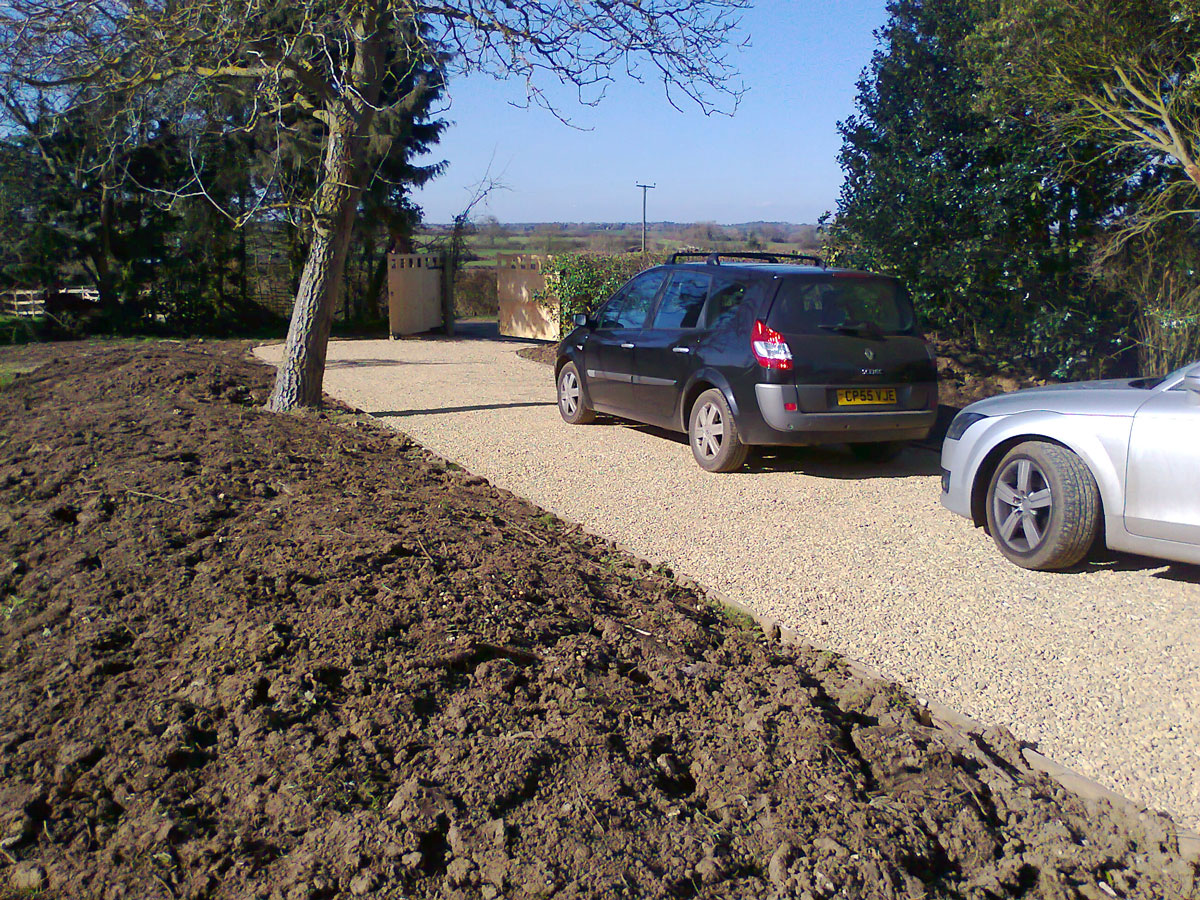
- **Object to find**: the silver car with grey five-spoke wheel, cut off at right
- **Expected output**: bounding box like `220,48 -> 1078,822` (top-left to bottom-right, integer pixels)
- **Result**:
942,362 -> 1200,569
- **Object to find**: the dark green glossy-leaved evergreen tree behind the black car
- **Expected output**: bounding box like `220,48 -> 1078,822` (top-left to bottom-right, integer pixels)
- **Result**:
829,0 -> 1120,373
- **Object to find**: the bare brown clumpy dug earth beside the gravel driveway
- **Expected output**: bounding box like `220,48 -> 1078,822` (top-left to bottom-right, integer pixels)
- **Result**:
0,342 -> 1200,900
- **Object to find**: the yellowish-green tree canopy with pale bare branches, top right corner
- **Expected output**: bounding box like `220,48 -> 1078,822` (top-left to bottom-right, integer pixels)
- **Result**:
971,0 -> 1200,243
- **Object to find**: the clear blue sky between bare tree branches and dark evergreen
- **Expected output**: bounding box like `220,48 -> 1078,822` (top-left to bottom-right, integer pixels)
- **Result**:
414,0 -> 887,223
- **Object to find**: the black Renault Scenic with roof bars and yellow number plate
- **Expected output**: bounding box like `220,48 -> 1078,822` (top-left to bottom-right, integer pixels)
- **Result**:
554,253 -> 937,472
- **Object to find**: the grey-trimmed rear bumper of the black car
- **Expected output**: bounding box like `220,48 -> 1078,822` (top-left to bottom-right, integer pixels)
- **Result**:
743,384 -> 937,444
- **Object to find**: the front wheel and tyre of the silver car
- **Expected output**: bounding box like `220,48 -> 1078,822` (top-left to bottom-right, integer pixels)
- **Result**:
986,440 -> 1100,570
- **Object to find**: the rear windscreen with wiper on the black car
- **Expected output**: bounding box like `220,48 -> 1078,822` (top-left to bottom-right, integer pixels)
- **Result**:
768,275 -> 914,334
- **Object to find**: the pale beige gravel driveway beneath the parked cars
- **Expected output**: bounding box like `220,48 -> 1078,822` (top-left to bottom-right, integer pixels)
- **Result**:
256,340 -> 1200,827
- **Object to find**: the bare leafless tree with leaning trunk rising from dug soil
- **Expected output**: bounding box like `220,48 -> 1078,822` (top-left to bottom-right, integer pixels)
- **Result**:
0,0 -> 750,409
